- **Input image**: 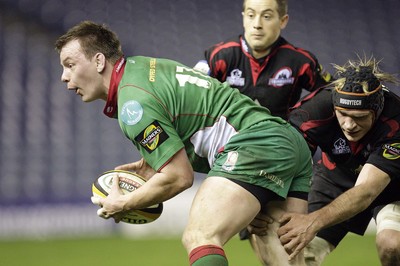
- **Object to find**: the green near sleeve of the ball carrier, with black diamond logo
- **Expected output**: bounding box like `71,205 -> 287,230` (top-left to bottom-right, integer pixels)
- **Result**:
118,86 -> 184,171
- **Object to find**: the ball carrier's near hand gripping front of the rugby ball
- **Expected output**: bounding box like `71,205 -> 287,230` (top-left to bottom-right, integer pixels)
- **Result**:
91,175 -> 125,223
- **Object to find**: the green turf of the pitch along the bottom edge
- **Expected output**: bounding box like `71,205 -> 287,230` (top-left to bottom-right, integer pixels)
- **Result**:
0,235 -> 380,266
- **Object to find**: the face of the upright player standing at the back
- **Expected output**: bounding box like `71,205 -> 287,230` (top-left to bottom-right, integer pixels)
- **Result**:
242,0 -> 289,58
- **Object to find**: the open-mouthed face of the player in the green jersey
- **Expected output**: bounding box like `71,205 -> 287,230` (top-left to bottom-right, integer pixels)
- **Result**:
60,40 -> 107,102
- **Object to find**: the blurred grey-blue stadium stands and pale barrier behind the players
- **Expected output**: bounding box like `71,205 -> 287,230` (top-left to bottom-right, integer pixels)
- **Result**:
0,0 -> 400,245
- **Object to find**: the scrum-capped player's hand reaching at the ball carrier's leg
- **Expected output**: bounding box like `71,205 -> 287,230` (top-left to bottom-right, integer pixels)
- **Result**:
278,213 -> 317,260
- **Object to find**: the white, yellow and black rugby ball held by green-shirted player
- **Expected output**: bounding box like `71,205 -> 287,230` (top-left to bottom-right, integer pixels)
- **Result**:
92,170 -> 163,224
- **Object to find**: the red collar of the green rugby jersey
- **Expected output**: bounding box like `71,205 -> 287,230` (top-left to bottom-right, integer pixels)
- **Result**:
103,57 -> 126,118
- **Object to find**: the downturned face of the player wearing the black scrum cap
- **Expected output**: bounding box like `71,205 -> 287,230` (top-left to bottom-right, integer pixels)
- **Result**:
335,109 -> 375,141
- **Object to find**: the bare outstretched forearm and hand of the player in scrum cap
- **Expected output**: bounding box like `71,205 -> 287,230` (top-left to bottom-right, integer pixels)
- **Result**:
278,164 -> 390,258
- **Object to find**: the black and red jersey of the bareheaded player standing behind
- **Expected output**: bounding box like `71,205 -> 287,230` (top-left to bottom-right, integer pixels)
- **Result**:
205,35 -> 330,120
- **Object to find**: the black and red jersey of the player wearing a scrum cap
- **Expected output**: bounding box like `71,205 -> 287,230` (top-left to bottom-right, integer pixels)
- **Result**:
289,88 -> 400,185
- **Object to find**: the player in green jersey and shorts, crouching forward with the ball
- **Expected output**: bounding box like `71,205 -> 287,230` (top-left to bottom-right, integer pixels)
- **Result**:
55,21 -> 312,266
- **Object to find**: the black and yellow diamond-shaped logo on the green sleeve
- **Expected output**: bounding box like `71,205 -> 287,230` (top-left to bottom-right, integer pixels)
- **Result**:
135,121 -> 169,153
